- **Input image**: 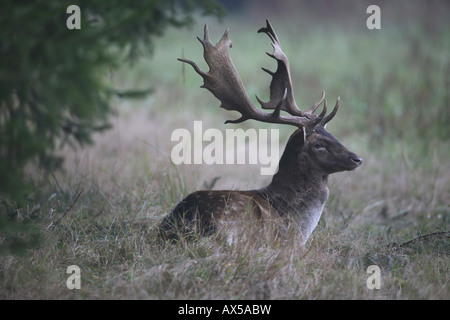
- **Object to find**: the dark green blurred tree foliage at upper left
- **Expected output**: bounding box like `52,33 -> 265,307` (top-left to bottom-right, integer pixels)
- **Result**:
0,0 -> 224,255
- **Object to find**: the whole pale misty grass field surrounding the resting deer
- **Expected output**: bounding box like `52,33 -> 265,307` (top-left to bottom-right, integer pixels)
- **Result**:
0,2 -> 450,299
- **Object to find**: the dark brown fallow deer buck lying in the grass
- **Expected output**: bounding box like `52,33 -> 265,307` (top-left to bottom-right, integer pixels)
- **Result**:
160,20 -> 362,244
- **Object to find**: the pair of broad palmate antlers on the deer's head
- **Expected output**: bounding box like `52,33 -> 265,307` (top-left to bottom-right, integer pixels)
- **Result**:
178,20 -> 339,131
